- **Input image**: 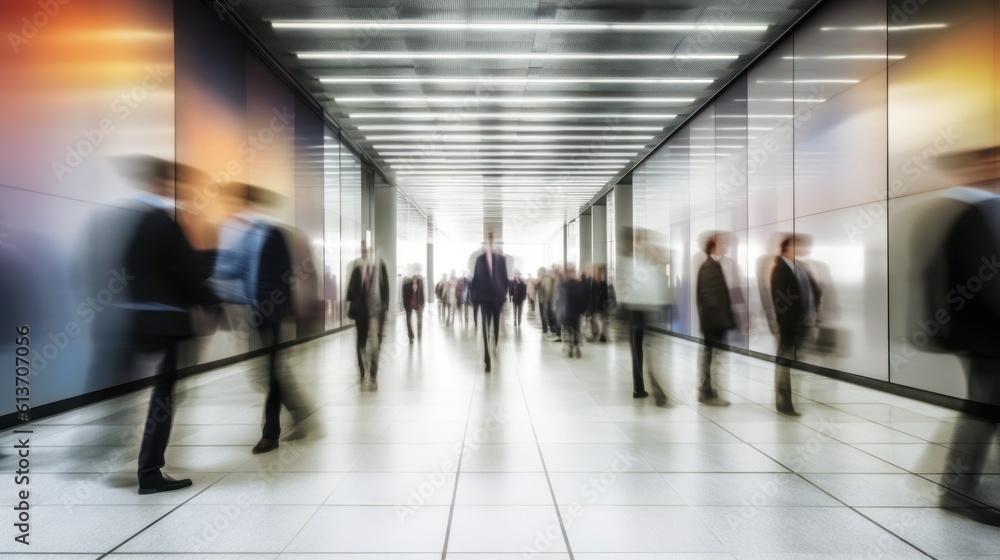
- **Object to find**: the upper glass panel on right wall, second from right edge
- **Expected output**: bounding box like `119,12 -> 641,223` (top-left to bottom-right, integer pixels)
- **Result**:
792,0 -> 888,216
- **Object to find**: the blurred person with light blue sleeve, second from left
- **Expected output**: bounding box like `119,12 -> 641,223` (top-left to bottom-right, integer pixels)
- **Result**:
212,183 -> 308,454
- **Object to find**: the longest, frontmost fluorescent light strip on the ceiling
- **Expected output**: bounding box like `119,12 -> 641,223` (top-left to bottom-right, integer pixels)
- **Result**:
271,20 -> 769,33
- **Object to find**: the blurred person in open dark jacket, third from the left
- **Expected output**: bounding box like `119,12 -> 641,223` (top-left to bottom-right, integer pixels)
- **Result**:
347,241 -> 389,389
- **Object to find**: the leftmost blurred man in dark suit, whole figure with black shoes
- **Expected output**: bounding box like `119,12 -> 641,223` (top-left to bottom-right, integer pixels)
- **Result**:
117,156 -> 219,494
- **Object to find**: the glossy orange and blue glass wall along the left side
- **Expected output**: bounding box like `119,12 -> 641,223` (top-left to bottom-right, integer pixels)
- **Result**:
0,0 -> 374,415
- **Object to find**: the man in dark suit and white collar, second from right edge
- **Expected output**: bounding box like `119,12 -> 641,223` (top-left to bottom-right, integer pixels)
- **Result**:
771,235 -> 823,416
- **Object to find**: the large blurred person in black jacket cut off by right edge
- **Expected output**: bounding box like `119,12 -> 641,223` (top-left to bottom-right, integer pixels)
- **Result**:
924,147 -> 1000,526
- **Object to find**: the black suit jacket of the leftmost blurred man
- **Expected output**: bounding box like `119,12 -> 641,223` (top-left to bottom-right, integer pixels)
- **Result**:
124,201 -> 219,344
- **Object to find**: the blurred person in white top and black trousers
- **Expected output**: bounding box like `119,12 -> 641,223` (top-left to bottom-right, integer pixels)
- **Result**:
619,228 -> 670,399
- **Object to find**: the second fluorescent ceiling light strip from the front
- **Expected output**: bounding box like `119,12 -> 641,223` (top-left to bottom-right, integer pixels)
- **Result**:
296,51 -> 739,60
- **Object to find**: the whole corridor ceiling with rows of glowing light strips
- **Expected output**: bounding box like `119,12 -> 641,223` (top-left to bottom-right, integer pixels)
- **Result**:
223,0 -> 817,243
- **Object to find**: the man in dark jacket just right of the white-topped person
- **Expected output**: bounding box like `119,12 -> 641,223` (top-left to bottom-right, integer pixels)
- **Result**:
695,233 -> 736,406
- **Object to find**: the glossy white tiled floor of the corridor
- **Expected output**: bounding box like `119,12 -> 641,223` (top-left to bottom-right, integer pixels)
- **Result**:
0,313 -> 1000,560
